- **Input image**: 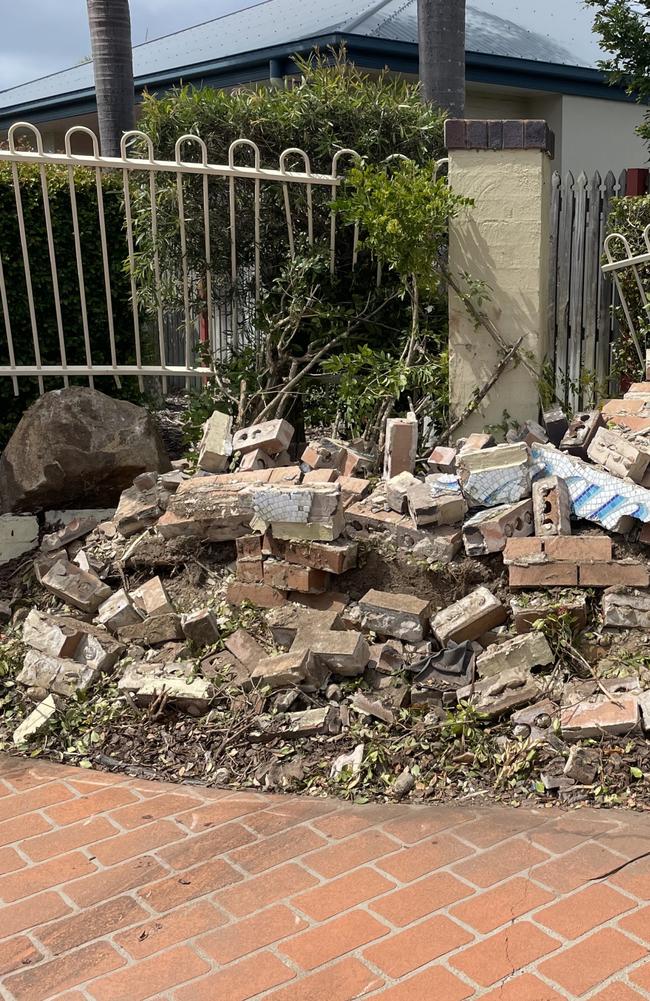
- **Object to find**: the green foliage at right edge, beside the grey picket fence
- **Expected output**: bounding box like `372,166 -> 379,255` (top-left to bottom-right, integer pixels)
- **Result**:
607,195 -> 650,381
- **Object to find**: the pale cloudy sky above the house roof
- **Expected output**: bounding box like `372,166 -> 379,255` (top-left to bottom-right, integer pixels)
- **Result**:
0,0 -> 598,90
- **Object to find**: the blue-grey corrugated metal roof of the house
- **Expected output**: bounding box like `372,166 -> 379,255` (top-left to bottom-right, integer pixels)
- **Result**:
0,0 -> 597,109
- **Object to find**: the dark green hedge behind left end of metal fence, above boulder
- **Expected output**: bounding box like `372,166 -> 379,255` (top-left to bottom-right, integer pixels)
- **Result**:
0,165 -> 140,447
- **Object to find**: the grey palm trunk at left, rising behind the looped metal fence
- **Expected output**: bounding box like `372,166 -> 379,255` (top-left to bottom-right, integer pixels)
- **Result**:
86,0 -> 135,156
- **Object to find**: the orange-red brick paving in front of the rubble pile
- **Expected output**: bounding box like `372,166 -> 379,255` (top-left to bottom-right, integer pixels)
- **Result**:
0,756 -> 650,1001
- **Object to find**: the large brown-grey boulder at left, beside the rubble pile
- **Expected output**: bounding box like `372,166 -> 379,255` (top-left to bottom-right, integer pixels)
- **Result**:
0,387 -> 171,514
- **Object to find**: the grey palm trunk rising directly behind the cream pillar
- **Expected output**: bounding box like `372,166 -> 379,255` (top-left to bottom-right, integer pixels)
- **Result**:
418,0 -> 465,118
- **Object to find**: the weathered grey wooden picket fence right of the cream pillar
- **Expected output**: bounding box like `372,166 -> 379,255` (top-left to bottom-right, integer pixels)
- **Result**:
549,170 -> 626,409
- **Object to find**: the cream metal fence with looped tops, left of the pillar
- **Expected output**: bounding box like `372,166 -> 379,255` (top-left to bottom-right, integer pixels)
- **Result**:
0,122 -> 359,393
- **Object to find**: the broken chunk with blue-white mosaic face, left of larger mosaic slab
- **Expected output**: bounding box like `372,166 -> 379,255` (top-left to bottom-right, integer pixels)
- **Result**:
457,442 -> 531,508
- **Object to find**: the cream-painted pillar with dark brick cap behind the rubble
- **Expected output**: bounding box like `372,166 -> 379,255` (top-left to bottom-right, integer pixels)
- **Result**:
446,119 -> 554,432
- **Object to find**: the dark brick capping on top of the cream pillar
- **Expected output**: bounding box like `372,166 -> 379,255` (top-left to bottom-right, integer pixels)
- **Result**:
445,118 -> 555,159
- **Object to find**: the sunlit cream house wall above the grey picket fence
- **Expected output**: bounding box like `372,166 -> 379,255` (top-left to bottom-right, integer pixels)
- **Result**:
562,95 -> 648,176
